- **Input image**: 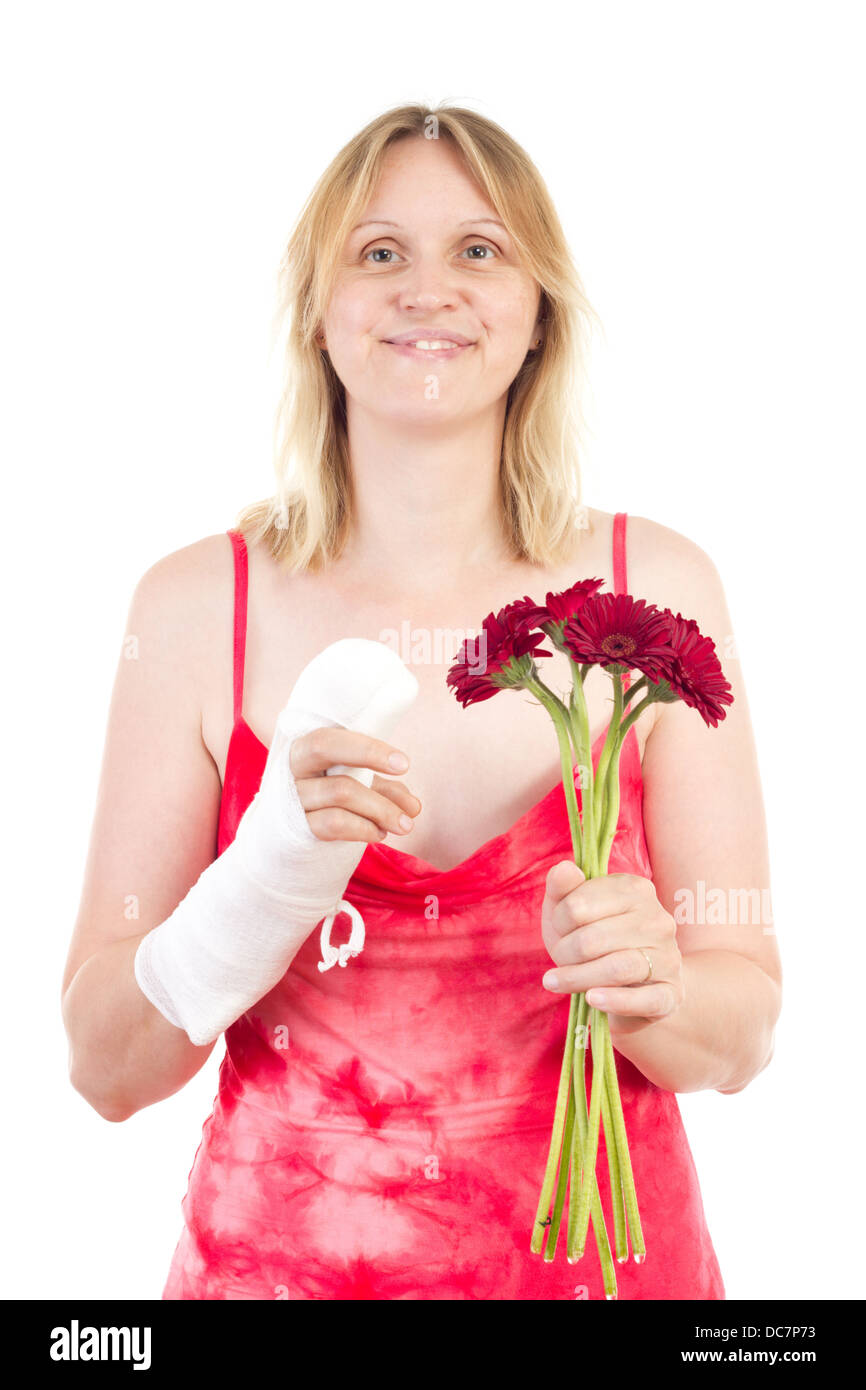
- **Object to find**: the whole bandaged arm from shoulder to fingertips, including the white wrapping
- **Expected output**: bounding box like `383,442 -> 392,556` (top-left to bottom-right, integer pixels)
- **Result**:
63,537 -> 420,1120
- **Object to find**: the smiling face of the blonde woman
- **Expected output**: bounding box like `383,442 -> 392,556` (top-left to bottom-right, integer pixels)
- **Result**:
322,138 -> 539,423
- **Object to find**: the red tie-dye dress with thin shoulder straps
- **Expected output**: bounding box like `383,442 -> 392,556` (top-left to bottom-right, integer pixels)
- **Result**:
163,513 -> 726,1300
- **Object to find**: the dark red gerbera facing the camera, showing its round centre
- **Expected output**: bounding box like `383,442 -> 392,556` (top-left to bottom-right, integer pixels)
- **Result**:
563,594 -> 674,681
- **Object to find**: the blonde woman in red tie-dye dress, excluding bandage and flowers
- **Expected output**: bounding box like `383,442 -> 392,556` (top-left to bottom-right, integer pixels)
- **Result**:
64,107 -> 781,1298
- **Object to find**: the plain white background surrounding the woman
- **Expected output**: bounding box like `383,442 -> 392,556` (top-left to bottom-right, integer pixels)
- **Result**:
0,0 -> 866,1298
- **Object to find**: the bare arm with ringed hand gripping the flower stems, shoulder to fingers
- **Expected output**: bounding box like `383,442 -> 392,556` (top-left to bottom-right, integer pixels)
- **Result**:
542,518 -> 781,1094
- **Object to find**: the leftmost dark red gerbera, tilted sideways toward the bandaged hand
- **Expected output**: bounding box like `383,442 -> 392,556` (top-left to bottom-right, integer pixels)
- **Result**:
445,598 -> 553,708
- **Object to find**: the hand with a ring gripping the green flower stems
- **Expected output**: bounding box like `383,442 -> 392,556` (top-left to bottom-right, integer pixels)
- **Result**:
541,859 -> 685,1038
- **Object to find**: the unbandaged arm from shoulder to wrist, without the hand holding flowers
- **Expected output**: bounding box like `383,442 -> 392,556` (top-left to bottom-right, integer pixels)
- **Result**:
612,518 -> 781,1095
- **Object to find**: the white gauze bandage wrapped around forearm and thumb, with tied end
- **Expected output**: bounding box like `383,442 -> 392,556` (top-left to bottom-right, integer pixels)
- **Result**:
135,637 -> 418,1047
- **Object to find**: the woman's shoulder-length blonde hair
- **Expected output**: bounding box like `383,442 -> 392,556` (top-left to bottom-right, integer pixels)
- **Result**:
235,106 -> 598,570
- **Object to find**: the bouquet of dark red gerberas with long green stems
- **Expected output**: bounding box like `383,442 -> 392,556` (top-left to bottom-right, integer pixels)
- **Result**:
446,580 -> 733,1298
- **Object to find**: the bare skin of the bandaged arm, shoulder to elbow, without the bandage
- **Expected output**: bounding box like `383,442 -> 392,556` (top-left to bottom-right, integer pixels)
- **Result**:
61,537 -> 231,1120
